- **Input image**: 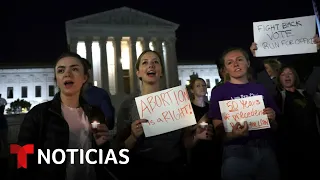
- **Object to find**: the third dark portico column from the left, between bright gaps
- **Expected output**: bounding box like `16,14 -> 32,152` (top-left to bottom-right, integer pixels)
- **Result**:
98,37 -> 109,92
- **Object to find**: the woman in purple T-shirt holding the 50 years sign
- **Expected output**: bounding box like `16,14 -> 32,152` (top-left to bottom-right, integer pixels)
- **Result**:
208,48 -> 279,180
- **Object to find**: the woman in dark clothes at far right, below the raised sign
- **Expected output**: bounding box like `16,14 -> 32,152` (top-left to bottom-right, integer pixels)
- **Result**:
277,66 -> 320,179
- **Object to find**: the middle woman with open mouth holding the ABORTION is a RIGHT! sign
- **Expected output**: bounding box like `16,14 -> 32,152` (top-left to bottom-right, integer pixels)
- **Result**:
115,50 -> 209,179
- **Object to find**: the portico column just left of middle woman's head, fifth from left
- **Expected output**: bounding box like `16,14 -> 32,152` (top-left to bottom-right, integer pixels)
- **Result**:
129,37 -> 138,94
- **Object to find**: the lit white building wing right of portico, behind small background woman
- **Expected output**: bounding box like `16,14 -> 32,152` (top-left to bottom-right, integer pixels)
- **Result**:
178,64 -> 220,98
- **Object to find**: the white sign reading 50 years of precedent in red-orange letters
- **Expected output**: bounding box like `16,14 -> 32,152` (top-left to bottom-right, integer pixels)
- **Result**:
219,95 -> 270,132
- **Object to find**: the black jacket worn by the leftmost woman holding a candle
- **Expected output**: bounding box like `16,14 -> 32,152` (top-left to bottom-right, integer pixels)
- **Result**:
15,95 -> 113,180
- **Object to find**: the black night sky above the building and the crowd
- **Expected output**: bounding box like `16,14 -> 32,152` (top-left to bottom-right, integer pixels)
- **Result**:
0,0 -> 319,64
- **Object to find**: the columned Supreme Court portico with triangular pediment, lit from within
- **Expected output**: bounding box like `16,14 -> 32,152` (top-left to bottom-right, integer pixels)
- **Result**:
66,7 -> 179,97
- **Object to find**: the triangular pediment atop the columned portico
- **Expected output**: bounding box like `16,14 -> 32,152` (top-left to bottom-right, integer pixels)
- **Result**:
66,7 -> 179,29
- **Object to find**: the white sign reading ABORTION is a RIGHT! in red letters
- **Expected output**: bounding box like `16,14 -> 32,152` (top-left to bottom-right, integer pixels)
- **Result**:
135,86 -> 197,137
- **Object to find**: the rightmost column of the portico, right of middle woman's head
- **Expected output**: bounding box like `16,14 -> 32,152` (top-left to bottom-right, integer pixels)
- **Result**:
166,37 -> 179,88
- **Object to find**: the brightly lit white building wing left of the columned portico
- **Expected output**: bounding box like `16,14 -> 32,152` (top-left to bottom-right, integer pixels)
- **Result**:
0,67 -> 57,113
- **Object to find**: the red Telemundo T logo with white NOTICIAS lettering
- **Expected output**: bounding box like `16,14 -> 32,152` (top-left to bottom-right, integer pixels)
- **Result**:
10,144 -> 129,169
